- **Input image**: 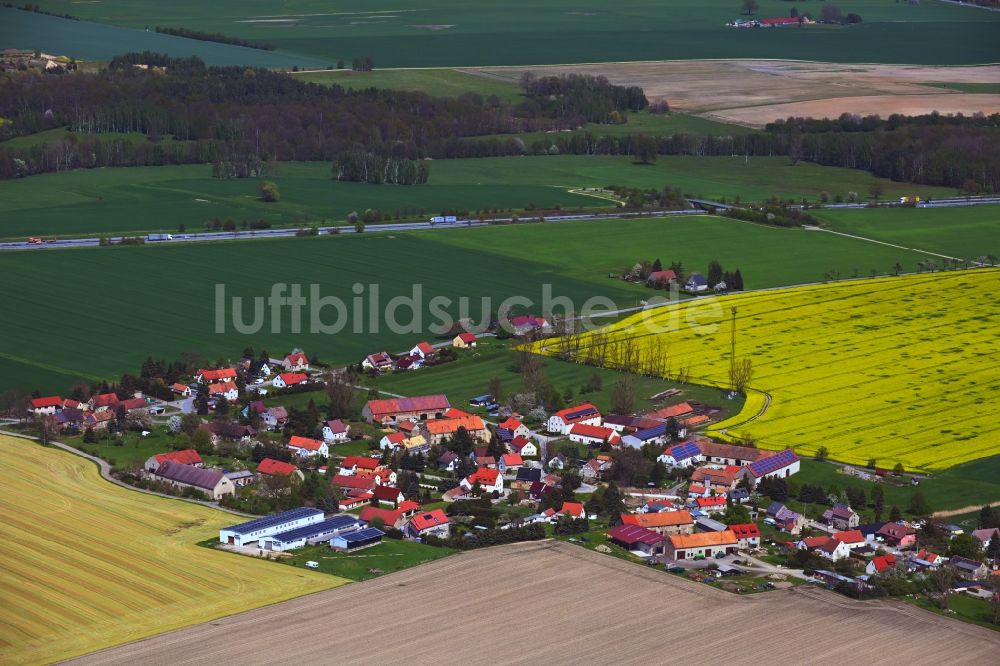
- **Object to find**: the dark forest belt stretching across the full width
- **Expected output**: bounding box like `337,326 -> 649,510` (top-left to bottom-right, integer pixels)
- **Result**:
0,53 -> 1000,193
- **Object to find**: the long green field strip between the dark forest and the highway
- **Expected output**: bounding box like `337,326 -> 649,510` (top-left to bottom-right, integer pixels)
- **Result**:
0,156 -> 953,239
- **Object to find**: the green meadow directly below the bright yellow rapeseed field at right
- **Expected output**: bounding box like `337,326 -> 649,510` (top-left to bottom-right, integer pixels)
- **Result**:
791,456 -> 1000,521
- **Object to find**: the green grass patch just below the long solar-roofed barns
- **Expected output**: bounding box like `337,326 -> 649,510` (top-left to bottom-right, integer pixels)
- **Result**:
278,539 -> 456,581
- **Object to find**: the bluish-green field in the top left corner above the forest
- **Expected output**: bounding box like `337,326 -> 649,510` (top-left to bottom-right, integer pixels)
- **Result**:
0,3 -> 326,68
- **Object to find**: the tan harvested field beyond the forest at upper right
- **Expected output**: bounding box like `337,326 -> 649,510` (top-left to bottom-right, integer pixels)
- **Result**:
472,60 -> 1000,125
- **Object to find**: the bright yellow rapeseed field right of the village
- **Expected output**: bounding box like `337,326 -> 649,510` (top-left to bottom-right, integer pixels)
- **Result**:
545,269 -> 1000,470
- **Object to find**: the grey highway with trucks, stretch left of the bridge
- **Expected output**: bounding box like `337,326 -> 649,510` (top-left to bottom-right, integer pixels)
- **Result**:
0,210 -> 705,250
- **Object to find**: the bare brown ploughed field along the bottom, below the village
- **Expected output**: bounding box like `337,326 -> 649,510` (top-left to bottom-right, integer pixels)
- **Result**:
74,542 -> 1000,665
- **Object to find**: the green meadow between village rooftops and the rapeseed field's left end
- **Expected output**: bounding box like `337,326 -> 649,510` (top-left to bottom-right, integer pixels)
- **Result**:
371,339 -> 742,419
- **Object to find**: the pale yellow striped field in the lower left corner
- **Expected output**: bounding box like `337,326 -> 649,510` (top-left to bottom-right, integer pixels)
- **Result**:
0,436 -> 347,664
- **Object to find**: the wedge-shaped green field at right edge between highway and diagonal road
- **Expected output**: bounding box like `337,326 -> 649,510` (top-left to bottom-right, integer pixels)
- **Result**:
816,206 -> 1000,259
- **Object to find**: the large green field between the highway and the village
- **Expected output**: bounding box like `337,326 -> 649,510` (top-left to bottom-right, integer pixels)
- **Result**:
0,213 -> 936,391
